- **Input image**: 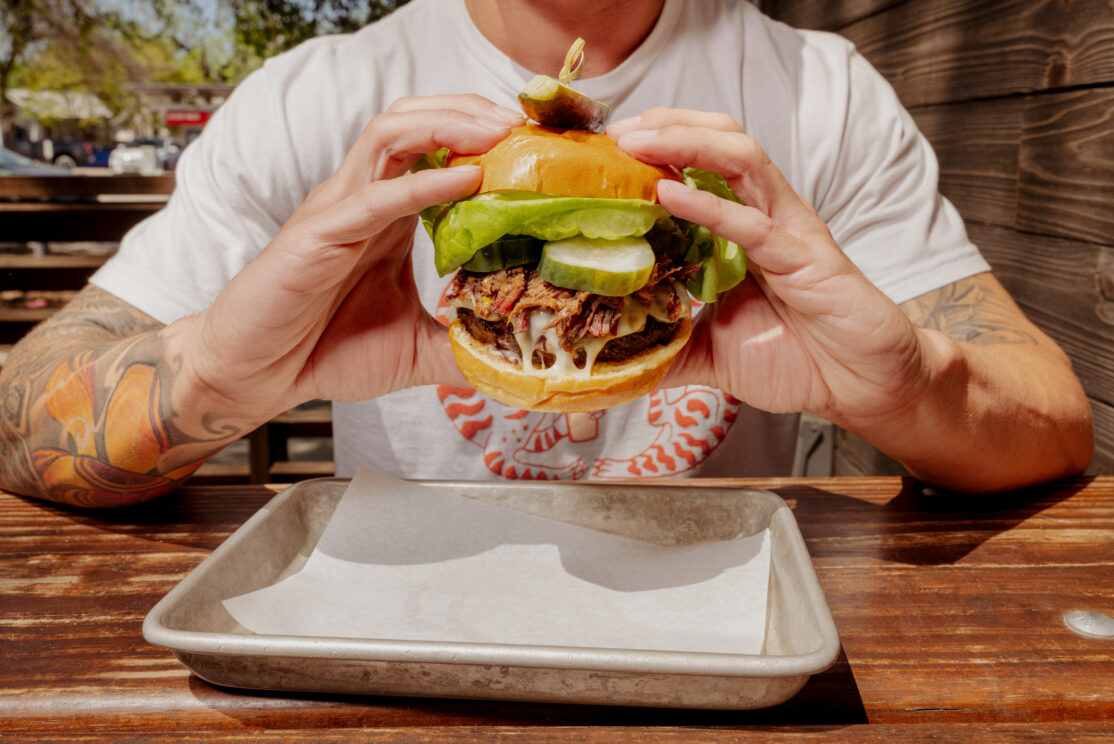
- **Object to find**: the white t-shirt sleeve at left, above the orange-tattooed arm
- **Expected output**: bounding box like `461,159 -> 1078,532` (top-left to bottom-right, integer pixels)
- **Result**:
90,60 -> 304,323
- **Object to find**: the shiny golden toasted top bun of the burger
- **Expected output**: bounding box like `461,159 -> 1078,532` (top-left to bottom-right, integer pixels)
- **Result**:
448,124 -> 677,202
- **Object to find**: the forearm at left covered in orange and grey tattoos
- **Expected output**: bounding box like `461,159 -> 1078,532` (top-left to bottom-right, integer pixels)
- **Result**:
0,287 -> 242,507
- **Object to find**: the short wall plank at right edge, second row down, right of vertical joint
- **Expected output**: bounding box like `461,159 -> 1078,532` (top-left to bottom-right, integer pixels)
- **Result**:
1017,86 -> 1114,245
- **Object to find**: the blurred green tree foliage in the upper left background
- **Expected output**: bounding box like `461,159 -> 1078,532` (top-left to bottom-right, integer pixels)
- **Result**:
0,0 -> 408,141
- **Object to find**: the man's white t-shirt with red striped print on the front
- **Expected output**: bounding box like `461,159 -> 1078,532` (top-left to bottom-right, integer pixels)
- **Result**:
92,0 -> 988,479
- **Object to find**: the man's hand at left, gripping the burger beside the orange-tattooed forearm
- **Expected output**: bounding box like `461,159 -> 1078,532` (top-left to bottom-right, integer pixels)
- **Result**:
167,96 -> 522,421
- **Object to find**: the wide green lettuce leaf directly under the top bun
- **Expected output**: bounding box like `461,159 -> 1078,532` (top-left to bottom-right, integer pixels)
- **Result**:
423,192 -> 670,276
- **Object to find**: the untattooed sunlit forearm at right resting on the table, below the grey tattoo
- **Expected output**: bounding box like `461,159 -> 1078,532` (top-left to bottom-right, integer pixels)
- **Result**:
844,331 -> 1093,492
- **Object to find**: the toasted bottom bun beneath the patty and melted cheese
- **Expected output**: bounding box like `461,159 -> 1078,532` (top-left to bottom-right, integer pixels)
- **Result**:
449,317 -> 692,413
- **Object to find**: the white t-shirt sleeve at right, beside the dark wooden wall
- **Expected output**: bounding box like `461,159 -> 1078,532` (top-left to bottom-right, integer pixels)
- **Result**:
799,37 -> 989,303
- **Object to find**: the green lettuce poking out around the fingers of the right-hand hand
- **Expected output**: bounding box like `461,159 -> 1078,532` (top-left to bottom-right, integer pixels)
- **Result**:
682,168 -> 746,302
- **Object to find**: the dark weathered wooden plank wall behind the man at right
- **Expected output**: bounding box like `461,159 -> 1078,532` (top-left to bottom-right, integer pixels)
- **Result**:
758,0 -> 1114,474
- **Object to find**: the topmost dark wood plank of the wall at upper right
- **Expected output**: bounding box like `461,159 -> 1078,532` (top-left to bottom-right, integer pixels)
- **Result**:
837,0 -> 1114,106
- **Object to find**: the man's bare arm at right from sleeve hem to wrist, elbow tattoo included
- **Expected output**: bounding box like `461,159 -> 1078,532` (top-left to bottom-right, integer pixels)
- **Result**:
843,274 -> 1094,491
